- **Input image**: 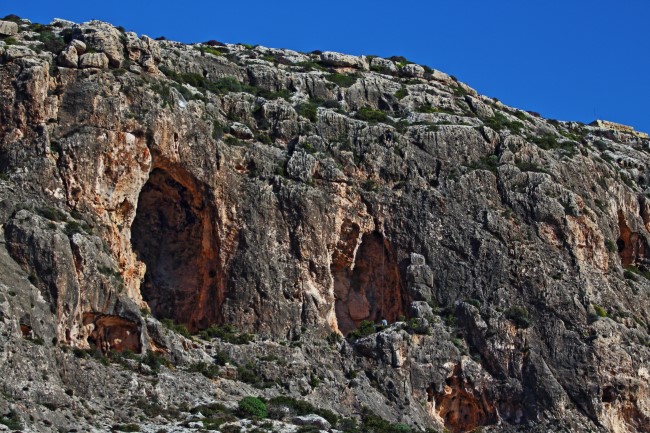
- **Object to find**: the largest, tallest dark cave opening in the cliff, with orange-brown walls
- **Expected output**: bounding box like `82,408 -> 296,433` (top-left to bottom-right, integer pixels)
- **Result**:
131,168 -> 223,330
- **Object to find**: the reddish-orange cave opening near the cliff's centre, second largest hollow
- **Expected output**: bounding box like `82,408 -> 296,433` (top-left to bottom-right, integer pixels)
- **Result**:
331,230 -> 404,335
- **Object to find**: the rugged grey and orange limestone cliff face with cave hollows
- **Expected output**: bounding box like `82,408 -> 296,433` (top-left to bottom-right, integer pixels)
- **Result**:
0,18 -> 650,433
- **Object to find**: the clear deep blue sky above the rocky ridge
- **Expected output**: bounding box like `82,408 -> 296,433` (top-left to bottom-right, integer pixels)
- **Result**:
5,0 -> 650,132
